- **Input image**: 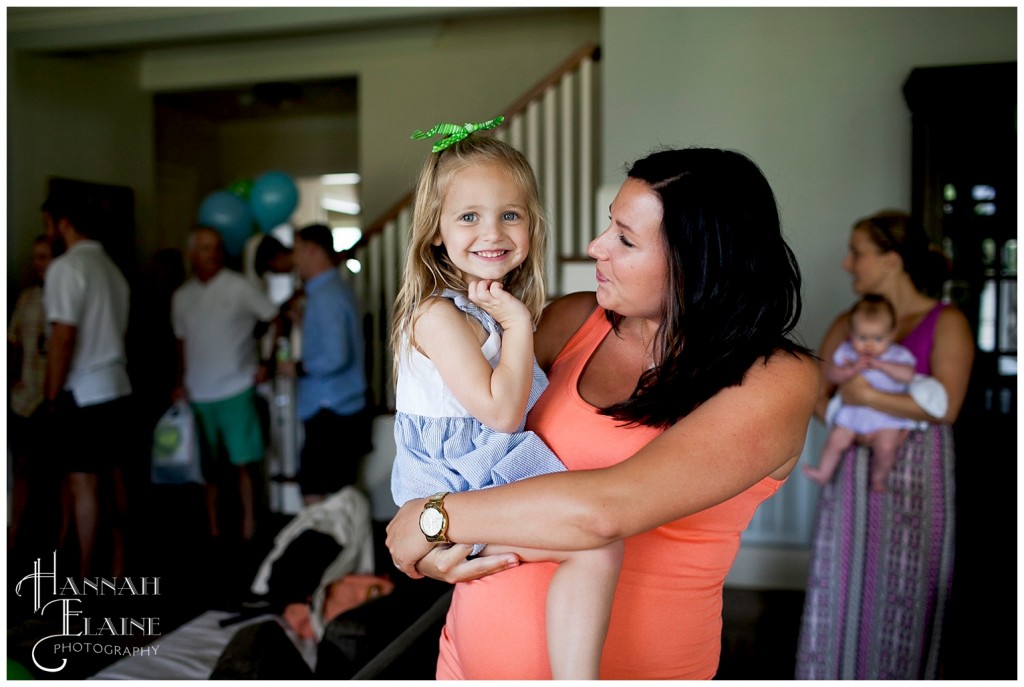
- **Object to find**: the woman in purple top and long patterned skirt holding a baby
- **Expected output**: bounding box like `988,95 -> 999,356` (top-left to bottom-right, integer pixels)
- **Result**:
796,211 -> 974,680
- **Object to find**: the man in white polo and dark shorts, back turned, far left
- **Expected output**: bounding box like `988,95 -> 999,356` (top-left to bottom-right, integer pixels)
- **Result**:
42,186 -> 131,576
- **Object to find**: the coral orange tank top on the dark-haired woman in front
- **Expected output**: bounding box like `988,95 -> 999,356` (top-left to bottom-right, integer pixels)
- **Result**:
437,308 -> 782,680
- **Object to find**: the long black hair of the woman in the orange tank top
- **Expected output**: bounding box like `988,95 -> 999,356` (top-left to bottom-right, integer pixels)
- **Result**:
603,148 -> 810,427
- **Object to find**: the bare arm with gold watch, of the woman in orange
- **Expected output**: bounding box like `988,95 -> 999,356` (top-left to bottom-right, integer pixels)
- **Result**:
388,346 -> 820,574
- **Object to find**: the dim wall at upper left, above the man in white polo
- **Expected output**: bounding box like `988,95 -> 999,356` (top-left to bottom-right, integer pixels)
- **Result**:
7,50 -> 154,292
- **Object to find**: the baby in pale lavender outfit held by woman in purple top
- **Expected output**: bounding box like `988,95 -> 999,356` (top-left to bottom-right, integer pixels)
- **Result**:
804,295 -> 918,491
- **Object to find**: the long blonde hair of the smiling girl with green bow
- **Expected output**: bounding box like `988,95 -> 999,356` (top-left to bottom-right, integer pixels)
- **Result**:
390,134 -> 548,375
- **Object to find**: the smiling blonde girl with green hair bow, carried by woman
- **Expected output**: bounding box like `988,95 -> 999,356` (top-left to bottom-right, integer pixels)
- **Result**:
391,119 -> 622,679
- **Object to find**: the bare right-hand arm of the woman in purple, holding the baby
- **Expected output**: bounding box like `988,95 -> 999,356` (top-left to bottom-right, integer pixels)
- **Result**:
841,307 -> 974,423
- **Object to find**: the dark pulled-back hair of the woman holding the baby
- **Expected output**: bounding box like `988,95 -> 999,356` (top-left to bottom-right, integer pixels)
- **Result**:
853,210 -> 949,297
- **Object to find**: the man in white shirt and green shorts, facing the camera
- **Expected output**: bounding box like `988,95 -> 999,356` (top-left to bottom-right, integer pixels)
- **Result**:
171,226 -> 278,541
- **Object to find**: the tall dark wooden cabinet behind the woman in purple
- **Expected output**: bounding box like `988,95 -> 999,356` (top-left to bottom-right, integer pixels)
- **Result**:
903,62 -> 1017,679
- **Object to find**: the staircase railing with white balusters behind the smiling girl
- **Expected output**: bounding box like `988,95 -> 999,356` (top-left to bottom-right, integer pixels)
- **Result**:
348,44 -> 600,413
